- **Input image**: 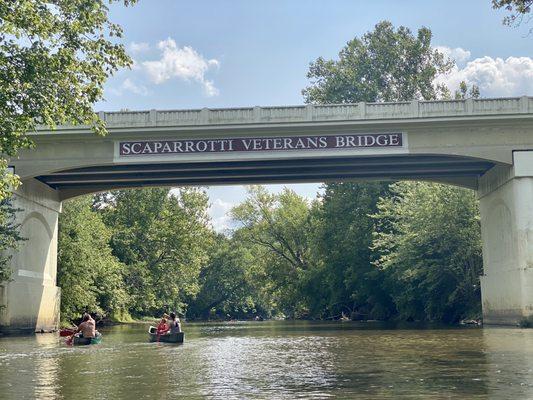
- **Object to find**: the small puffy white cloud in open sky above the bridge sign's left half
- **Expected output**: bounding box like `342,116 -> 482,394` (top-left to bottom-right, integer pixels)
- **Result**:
142,38 -> 219,96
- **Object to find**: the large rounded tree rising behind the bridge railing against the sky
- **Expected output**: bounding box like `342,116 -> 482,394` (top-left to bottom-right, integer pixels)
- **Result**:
302,21 -> 453,104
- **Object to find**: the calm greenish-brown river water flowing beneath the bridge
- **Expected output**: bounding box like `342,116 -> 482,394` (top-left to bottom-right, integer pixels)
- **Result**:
0,321 -> 533,400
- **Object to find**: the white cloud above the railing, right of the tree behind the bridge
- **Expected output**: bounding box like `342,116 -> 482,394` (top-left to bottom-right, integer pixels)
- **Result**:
436,56 -> 533,97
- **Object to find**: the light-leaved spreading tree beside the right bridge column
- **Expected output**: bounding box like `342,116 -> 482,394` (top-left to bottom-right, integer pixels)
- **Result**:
373,182 -> 482,322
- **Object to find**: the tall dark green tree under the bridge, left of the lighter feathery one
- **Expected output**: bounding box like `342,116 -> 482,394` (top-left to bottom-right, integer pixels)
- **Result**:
310,182 -> 394,319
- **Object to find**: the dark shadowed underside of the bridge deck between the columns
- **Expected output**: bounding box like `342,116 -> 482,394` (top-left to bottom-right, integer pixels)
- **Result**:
37,155 -> 494,198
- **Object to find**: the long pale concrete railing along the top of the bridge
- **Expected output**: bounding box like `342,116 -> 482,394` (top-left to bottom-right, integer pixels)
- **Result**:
47,96 -> 533,129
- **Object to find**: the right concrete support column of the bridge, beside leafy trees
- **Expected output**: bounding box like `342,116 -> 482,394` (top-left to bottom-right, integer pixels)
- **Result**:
478,151 -> 533,325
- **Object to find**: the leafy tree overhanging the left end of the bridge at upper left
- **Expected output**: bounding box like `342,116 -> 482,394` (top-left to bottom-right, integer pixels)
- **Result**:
0,0 -> 136,199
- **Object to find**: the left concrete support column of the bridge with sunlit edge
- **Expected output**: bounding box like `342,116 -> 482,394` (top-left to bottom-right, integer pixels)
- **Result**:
0,179 -> 61,333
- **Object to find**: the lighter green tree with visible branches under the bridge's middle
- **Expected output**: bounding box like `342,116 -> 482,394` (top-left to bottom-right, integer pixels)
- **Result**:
231,186 -> 314,316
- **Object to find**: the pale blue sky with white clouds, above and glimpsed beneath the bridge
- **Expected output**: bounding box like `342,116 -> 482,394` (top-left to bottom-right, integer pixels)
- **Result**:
96,0 -> 533,231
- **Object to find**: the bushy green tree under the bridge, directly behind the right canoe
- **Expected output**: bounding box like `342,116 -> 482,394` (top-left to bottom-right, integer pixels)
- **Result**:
96,189 -> 212,315
